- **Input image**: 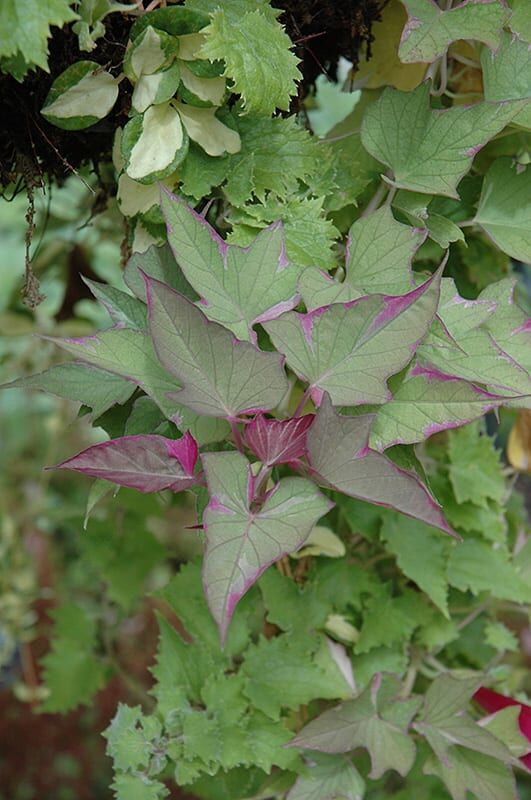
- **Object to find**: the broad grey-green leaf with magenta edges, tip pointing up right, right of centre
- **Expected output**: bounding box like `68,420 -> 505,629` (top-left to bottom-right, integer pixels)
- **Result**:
263,271 -> 440,406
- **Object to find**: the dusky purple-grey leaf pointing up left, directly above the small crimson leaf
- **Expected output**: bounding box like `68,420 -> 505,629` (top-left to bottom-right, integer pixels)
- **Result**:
146,279 -> 288,420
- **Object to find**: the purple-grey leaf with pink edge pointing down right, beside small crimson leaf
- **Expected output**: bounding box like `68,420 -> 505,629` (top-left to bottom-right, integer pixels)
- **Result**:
307,395 -> 451,533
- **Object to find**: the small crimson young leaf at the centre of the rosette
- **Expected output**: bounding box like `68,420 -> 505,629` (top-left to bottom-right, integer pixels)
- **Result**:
244,414 -> 314,466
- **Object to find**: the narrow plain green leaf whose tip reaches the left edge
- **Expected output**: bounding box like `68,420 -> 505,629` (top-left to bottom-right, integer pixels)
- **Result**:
1,364 -> 135,418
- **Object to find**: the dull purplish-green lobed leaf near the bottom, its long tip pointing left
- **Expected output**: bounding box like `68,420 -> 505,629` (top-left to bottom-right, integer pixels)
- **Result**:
290,674 -> 421,779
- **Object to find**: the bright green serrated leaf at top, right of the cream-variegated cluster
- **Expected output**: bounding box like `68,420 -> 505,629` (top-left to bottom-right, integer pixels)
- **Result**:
199,8 -> 301,115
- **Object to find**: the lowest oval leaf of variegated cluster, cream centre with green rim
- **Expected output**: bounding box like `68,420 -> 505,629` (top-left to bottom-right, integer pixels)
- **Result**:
121,103 -> 188,183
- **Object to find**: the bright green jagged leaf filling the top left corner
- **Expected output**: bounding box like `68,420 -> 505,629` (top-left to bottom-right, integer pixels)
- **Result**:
0,0 -> 77,75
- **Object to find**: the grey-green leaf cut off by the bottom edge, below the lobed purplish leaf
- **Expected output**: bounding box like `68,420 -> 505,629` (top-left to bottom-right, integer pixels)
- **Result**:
287,753 -> 365,800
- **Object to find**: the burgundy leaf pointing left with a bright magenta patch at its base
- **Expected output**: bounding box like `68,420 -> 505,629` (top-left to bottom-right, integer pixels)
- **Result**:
55,433 -> 199,492
